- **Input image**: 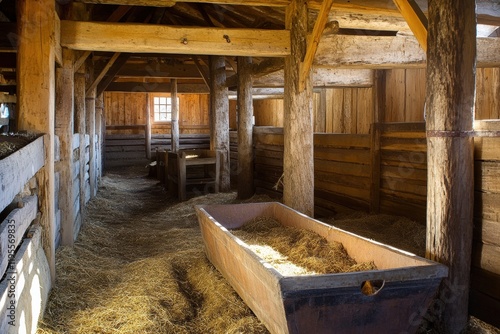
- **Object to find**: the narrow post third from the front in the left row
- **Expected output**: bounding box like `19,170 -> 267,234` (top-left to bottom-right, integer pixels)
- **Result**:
74,65 -> 86,232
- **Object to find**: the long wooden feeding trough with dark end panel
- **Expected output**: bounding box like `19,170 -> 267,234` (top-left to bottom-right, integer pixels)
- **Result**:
196,202 -> 448,334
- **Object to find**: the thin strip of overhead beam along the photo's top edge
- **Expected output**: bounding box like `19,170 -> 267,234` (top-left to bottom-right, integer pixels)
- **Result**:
77,0 -> 290,7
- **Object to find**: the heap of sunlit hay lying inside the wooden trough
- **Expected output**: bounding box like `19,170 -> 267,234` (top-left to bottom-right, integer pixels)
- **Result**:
232,217 -> 376,276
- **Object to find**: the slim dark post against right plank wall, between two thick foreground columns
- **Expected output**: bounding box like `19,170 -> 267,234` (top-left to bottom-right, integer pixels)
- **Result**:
370,70 -> 386,213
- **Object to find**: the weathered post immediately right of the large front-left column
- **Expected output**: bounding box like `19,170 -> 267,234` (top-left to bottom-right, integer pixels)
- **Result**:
55,49 -> 75,246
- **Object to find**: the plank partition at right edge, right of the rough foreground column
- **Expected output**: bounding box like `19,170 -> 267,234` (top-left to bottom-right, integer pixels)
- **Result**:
470,120 -> 500,327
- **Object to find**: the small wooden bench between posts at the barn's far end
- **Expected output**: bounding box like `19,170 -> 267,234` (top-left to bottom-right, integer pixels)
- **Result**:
167,150 -> 220,201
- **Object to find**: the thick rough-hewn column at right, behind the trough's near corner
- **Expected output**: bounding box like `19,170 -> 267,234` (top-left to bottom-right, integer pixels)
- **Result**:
426,0 -> 476,333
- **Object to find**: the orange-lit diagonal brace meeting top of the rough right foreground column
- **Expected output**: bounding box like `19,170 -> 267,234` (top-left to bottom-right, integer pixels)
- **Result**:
394,0 -> 428,52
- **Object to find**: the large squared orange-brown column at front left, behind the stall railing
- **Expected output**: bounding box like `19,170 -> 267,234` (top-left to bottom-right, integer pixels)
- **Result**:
16,0 -> 56,282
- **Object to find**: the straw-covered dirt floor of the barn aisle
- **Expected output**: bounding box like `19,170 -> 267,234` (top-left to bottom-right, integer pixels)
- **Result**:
37,167 -> 500,334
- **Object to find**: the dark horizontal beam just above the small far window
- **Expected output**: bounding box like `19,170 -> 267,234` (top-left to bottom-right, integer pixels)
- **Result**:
106,82 -> 209,94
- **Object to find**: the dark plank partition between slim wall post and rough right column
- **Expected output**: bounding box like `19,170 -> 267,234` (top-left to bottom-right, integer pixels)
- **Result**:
379,122 -> 427,223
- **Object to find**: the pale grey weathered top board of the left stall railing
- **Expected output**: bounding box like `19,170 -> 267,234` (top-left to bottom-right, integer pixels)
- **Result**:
0,137 -> 44,211
